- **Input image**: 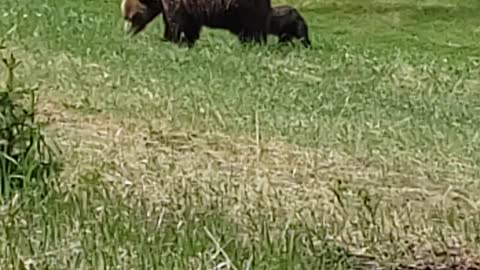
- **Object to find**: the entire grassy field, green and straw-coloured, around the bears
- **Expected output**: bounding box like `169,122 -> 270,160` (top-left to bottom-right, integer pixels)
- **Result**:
0,0 -> 480,269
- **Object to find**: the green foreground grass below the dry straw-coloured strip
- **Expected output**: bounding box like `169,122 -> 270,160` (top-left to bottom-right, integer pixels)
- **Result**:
0,174 -> 349,269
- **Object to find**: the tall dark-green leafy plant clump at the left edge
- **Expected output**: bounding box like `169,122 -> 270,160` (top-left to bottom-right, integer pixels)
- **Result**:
0,42 -> 58,200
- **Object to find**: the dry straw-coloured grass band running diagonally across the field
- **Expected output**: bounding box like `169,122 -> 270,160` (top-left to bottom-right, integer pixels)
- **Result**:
33,96 -> 478,264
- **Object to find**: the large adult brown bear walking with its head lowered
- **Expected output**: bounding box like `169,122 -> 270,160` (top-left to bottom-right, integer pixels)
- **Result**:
121,0 -> 271,46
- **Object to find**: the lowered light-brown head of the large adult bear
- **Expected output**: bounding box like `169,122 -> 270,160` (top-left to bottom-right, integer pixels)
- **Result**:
120,0 -> 163,35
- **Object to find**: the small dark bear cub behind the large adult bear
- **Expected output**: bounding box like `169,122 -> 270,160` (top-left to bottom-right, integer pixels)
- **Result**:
269,5 -> 311,47
